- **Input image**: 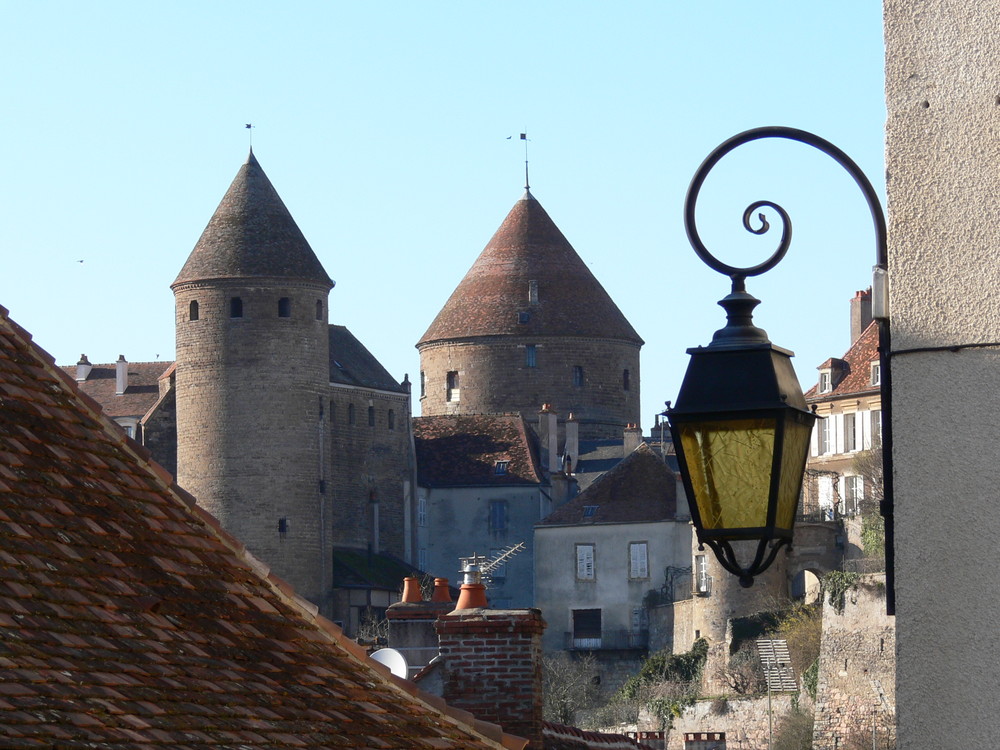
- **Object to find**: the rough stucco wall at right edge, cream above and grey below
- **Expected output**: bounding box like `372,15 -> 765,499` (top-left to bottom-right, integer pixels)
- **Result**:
884,0 -> 1000,748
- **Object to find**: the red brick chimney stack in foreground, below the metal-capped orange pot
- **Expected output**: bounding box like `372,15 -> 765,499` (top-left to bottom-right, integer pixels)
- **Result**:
435,609 -> 545,748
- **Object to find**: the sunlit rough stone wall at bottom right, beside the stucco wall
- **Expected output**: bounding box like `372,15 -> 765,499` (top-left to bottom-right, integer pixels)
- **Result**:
813,576 -> 896,750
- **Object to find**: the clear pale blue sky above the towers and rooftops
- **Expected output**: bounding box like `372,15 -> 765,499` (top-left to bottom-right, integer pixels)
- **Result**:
0,0 -> 885,429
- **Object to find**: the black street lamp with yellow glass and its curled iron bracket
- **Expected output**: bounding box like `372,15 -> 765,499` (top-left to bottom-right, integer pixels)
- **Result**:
666,127 -> 890,587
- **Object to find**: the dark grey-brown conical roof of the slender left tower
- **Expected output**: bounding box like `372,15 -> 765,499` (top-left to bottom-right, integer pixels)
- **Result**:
173,151 -> 333,287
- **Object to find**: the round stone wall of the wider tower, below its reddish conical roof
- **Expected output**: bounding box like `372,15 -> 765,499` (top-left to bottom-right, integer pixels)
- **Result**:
420,336 -> 640,440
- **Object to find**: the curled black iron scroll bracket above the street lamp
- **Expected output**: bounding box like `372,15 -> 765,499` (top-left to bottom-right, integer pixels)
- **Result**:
684,126 -> 888,284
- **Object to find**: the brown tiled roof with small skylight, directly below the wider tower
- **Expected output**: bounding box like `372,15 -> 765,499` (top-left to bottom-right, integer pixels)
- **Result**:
413,414 -> 542,487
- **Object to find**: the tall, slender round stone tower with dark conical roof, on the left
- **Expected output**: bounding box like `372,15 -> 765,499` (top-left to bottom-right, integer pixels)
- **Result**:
171,151 -> 333,603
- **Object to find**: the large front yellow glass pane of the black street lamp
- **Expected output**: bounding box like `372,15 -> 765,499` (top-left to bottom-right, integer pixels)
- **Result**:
679,419 -> 776,530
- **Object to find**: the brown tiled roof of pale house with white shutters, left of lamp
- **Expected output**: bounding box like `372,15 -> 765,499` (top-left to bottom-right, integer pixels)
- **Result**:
539,443 -> 677,526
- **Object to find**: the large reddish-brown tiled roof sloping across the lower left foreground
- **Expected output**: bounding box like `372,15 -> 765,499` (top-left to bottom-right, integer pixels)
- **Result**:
0,308 -> 523,748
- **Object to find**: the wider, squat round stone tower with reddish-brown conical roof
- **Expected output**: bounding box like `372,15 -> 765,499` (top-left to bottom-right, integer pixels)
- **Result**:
417,190 -> 643,439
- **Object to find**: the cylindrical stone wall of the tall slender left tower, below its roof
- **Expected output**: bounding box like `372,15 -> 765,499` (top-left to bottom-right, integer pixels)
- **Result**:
175,279 -> 331,611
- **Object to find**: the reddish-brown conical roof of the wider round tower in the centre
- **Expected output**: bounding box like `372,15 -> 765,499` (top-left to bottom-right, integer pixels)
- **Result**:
417,191 -> 643,346
